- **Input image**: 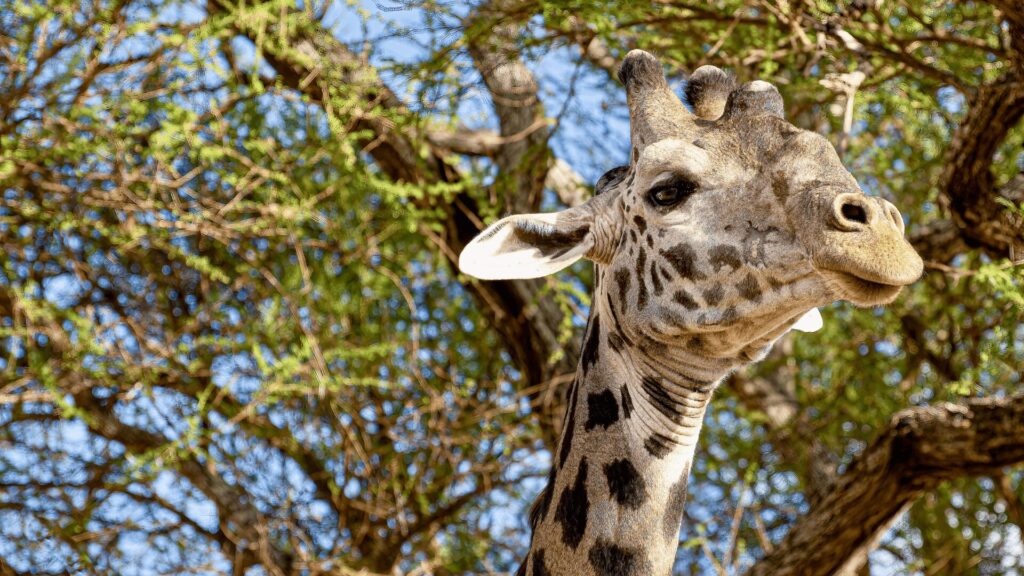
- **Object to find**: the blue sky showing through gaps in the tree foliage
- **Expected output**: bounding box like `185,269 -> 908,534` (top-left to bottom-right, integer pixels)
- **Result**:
0,2 -> 1019,574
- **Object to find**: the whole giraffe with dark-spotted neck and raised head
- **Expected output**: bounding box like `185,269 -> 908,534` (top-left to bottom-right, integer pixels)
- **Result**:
460,50 -> 923,576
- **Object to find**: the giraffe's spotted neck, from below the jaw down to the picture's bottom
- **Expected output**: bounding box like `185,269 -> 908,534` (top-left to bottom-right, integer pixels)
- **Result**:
520,298 -> 739,576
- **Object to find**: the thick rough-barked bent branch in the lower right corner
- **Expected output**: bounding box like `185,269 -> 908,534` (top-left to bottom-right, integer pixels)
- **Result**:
748,396 -> 1024,576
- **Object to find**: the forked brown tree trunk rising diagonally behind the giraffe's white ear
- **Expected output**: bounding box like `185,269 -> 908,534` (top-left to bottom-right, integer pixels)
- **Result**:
210,0 -> 580,448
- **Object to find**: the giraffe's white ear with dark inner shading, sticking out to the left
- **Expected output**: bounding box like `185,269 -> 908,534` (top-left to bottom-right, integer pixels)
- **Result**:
459,206 -> 594,280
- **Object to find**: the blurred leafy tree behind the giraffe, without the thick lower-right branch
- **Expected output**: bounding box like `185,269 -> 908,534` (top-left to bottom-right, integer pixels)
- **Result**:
0,0 -> 1024,575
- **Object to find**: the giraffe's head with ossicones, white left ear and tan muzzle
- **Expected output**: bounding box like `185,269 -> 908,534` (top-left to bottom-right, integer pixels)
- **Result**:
460,50 -> 923,359
